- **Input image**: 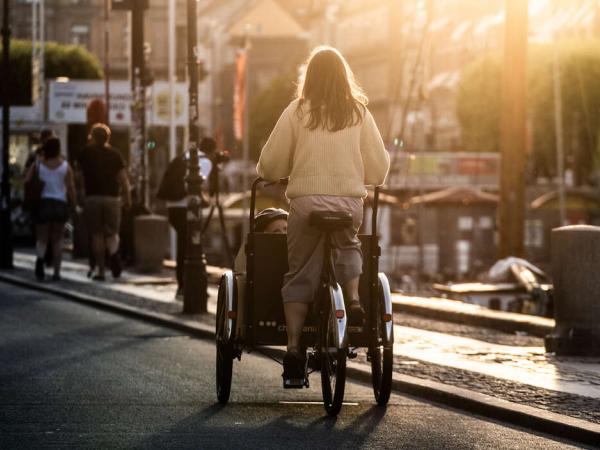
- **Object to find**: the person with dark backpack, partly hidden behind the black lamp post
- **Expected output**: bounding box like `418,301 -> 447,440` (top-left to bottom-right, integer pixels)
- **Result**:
156,138 -> 215,297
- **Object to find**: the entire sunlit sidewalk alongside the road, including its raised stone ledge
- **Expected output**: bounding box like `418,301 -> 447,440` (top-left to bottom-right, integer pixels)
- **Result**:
0,252 -> 600,436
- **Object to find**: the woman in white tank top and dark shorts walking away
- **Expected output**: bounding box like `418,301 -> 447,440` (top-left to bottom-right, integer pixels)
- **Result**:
26,136 -> 76,281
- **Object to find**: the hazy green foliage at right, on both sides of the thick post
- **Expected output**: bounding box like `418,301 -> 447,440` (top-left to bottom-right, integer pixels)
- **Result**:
457,40 -> 600,183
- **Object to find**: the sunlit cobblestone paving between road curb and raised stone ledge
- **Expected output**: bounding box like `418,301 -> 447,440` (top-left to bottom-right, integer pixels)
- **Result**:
8,253 -> 600,423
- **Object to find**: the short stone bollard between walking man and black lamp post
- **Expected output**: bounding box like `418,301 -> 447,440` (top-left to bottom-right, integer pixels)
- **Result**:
134,214 -> 169,273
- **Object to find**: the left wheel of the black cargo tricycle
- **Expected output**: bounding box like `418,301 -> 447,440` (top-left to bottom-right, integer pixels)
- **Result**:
215,277 -> 233,405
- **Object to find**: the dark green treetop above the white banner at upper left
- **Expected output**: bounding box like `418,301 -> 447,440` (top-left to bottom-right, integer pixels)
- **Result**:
0,39 -> 103,105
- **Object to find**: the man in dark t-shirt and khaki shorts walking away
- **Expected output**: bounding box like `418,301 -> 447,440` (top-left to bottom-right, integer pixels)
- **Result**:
77,123 -> 131,281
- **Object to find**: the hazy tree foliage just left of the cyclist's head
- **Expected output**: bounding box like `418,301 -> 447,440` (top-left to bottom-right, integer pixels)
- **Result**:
249,74 -> 295,161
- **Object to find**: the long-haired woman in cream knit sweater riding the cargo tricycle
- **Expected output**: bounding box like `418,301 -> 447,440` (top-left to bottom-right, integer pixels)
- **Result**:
257,47 -> 390,381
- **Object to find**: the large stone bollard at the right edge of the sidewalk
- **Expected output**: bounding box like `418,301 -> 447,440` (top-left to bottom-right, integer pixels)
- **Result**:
545,225 -> 600,356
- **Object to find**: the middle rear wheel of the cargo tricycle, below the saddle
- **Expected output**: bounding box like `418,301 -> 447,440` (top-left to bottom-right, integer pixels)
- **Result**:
319,291 -> 347,416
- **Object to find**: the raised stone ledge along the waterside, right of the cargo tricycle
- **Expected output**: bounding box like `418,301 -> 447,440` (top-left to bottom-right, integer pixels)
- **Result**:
392,294 -> 554,337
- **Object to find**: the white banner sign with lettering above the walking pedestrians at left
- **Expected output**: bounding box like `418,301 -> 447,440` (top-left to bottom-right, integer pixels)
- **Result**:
48,80 -> 188,126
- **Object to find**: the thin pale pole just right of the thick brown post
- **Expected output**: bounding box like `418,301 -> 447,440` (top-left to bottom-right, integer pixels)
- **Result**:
552,32 -> 566,226
